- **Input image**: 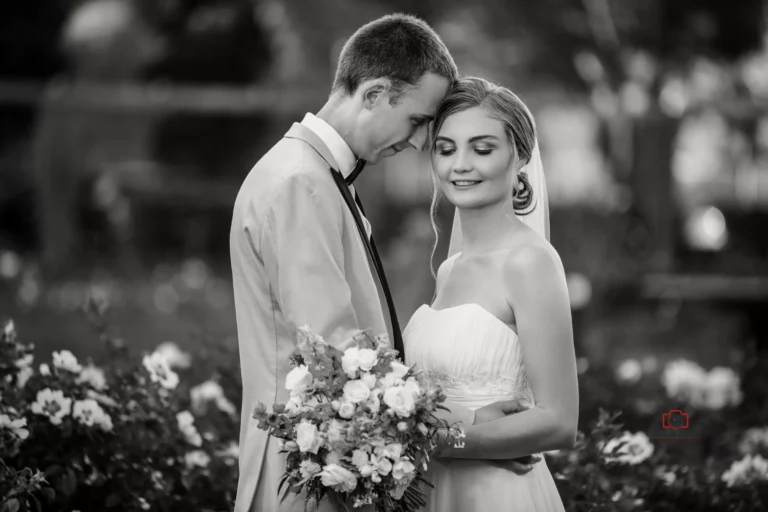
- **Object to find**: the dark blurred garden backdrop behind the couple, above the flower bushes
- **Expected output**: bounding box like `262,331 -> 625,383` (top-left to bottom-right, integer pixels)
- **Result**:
0,0 -> 768,390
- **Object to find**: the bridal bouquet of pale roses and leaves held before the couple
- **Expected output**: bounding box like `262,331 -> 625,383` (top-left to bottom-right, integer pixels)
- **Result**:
253,327 -> 464,512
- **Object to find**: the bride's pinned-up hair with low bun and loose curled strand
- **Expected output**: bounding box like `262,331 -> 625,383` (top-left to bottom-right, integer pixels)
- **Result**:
431,77 -> 536,273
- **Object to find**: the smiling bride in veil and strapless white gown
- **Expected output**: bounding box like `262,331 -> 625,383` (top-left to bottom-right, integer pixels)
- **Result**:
405,78 -> 579,512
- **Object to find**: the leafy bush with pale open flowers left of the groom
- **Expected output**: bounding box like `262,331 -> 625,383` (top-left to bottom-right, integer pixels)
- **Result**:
0,302 -> 239,512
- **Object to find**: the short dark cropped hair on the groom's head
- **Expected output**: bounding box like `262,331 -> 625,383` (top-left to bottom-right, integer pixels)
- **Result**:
332,13 -> 459,103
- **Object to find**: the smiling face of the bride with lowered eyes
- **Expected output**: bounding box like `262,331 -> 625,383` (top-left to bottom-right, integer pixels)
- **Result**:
432,107 -> 515,208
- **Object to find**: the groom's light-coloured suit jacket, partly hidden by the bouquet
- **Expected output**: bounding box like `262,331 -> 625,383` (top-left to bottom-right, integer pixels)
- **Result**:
230,123 -> 387,512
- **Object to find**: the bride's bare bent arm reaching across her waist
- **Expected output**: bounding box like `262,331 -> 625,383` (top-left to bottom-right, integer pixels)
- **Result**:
436,247 -> 579,459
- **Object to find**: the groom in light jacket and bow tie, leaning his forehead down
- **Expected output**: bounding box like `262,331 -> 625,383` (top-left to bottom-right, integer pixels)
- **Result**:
230,14 -> 527,512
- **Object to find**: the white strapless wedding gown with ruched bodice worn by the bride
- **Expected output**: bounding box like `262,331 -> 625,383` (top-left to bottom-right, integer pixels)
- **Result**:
404,304 -> 565,512
